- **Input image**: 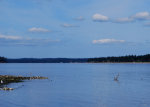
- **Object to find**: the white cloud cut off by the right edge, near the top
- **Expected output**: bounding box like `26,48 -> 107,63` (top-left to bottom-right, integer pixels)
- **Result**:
132,12 -> 150,20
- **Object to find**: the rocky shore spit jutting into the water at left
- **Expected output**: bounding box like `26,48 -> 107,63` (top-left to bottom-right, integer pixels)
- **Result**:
0,75 -> 48,90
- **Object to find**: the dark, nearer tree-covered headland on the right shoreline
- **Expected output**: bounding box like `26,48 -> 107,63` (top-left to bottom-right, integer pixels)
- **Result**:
88,54 -> 150,63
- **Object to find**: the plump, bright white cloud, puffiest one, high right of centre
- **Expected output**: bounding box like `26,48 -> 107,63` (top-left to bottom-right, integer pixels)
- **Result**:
92,13 -> 109,22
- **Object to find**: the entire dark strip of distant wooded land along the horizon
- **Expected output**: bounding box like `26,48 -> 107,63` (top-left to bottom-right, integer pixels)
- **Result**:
0,54 -> 150,63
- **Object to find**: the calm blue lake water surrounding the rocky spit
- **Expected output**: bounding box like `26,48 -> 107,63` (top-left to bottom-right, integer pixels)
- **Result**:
0,64 -> 150,107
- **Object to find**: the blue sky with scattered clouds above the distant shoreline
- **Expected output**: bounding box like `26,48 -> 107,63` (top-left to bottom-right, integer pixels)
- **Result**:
0,0 -> 150,58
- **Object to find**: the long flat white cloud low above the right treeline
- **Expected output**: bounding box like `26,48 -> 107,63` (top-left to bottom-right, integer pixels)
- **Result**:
93,39 -> 125,44
